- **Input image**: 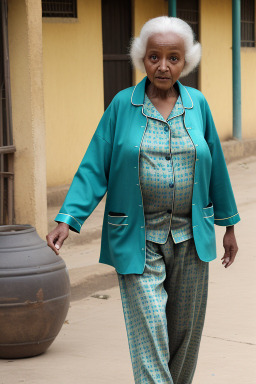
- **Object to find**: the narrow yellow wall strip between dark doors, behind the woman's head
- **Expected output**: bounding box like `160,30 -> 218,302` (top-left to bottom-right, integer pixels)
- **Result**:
133,0 -> 168,84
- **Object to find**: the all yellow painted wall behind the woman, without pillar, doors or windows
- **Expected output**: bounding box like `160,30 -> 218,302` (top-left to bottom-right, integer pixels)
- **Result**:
43,0 -> 256,186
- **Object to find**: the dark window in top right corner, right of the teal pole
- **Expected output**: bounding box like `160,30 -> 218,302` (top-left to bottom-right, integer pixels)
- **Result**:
241,0 -> 255,47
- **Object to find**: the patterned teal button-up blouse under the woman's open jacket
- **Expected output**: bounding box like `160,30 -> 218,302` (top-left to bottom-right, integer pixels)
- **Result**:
140,94 -> 195,244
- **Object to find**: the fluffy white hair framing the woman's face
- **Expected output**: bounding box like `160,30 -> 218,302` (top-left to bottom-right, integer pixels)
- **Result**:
130,16 -> 201,77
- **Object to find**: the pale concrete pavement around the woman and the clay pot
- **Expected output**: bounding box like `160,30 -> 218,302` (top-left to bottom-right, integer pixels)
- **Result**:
0,157 -> 256,384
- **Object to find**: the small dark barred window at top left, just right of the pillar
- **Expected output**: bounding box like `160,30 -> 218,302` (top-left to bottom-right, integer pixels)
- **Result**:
42,0 -> 77,17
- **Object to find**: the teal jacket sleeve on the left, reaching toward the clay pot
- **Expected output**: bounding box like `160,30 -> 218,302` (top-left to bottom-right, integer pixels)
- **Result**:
55,102 -> 114,233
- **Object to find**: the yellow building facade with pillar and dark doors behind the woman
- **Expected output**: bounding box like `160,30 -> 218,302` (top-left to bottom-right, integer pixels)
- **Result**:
1,0 -> 256,234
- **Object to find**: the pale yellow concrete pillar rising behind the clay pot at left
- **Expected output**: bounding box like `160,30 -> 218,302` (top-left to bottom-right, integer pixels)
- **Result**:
8,0 -> 47,238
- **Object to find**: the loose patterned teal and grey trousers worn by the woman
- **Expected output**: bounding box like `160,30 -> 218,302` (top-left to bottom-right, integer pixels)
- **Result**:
117,236 -> 209,384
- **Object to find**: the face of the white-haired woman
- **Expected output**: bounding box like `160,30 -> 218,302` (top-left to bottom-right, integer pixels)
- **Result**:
143,33 -> 185,91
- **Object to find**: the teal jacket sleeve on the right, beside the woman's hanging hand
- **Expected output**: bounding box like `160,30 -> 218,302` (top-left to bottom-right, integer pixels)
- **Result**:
205,100 -> 240,226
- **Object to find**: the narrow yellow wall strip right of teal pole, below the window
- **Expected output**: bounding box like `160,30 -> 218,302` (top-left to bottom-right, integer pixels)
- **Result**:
241,47 -> 256,139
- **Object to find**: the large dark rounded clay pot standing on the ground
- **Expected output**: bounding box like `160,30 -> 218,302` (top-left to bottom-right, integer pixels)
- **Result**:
0,225 -> 70,358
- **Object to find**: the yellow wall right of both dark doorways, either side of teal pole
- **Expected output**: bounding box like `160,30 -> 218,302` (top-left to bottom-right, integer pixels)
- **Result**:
200,0 -> 256,140
